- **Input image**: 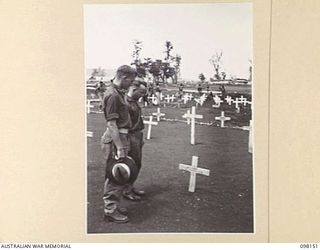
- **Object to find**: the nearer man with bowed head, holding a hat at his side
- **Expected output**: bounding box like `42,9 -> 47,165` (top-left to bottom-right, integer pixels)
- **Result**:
101,65 -> 136,223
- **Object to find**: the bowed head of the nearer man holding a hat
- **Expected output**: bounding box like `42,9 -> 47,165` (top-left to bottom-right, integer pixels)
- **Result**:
113,65 -> 137,89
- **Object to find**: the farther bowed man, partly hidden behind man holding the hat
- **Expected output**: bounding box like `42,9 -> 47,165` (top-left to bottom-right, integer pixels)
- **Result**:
123,79 -> 147,201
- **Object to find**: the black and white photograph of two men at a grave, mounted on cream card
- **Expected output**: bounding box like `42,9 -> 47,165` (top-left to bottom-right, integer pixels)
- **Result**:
83,3 -> 255,234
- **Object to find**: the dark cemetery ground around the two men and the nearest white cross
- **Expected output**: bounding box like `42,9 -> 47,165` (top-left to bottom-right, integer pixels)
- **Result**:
87,107 -> 253,233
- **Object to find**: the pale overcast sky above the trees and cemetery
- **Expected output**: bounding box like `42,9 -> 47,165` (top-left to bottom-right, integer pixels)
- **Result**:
84,3 -> 252,79
